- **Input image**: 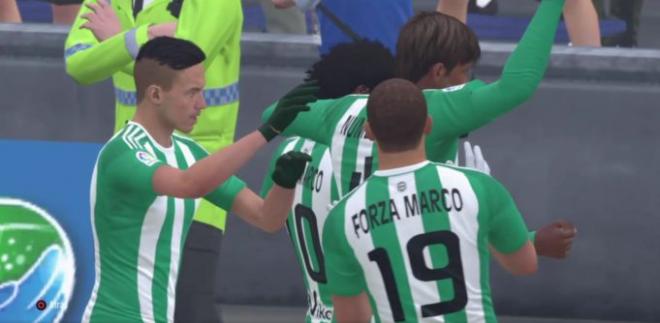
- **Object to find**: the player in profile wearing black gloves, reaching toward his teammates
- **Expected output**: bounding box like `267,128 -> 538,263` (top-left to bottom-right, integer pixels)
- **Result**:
83,38 -> 316,322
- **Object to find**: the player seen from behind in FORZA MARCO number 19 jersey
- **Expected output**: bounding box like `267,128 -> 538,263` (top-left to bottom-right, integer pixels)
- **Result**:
323,79 -> 537,323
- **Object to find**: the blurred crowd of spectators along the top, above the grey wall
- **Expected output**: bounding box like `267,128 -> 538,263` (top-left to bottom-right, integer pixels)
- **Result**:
0,0 -> 660,48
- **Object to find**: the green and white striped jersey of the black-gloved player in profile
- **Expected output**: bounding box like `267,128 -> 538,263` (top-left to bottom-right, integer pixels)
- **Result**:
83,122 -> 245,322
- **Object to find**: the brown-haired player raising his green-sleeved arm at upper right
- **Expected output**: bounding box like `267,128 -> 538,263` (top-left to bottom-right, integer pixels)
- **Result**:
264,0 -> 576,258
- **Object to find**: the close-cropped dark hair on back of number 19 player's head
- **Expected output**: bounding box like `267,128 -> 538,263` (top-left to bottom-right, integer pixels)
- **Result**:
367,79 -> 428,152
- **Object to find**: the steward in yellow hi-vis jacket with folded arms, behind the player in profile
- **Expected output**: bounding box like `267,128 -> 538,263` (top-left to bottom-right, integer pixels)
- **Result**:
65,0 -> 243,323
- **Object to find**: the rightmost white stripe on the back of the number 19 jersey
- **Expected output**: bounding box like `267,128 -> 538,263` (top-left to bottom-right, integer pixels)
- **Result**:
437,166 -> 485,322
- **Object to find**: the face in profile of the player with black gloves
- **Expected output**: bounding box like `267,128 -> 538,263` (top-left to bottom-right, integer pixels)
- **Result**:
165,64 -> 206,133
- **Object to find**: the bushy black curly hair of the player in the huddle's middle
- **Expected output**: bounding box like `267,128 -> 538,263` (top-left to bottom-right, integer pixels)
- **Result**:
306,40 -> 394,99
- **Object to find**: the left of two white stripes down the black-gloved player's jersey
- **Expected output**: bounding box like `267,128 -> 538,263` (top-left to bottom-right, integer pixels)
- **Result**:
137,196 -> 167,322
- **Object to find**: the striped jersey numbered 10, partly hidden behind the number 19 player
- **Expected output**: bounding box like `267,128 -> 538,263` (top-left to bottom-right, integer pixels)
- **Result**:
261,137 -> 338,323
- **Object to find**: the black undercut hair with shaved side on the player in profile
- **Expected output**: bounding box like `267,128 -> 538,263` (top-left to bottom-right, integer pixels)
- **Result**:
134,37 -> 206,102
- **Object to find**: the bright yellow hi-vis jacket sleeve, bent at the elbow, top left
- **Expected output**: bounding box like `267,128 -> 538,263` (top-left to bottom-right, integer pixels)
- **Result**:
64,0 -> 149,84
